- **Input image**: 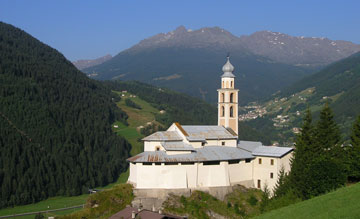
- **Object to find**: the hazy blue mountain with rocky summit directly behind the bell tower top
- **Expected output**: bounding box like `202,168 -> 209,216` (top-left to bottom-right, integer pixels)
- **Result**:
84,27 -> 311,104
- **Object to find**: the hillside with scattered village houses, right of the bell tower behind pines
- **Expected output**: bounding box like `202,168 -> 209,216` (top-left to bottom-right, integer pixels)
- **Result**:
240,52 -> 360,144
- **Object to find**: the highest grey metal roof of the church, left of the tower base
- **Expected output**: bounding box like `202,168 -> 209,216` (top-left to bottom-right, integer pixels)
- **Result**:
182,125 -> 237,141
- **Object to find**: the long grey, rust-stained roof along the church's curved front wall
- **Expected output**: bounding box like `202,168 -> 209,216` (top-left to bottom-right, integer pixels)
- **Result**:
127,146 -> 254,163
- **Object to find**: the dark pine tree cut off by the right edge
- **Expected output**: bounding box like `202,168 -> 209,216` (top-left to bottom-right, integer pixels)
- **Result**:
348,115 -> 360,181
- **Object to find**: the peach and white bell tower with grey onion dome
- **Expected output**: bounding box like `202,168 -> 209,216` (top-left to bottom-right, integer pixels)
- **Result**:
218,56 -> 239,135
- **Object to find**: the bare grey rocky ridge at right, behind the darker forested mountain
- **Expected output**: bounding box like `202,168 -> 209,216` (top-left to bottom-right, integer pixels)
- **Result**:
240,31 -> 360,66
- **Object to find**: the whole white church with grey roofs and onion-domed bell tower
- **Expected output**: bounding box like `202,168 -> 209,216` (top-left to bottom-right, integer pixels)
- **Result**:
128,57 -> 293,191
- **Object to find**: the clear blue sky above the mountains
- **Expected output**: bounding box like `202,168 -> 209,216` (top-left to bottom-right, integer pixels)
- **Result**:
0,0 -> 360,61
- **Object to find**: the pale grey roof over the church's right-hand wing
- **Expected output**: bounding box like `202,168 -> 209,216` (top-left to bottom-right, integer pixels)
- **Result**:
237,141 -> 293,157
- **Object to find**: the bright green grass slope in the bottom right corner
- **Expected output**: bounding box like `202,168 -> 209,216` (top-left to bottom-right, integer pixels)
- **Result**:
256,183 -> 360,219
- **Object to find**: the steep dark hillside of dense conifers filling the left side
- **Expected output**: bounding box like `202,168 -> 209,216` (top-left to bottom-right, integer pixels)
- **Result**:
0,22 -> 130,207
